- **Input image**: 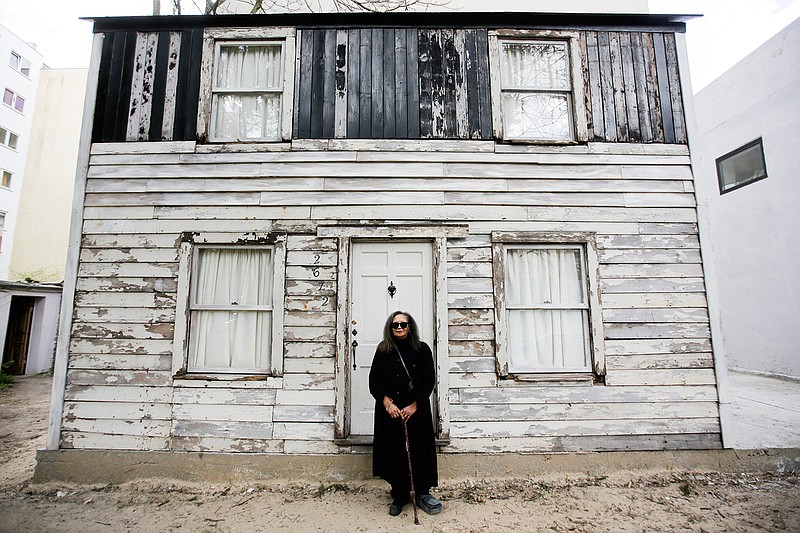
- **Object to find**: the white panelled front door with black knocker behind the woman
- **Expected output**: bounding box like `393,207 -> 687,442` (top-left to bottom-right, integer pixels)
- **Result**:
348,242 -> 434,435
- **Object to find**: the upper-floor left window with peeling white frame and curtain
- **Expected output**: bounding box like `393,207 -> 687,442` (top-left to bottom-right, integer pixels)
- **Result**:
198,28 -> 295,142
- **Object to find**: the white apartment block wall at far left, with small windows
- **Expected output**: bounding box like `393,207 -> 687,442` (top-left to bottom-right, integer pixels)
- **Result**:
0,25 -> 42,280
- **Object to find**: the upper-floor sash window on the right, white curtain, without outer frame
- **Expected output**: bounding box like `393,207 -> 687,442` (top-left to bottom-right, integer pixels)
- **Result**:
500,40 -> 574,141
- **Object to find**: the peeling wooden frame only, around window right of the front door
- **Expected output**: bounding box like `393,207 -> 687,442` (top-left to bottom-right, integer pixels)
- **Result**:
492,232 -> 606,382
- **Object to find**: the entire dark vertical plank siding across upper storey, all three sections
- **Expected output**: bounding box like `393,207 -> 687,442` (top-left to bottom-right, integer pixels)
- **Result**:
92,28 -> 687,143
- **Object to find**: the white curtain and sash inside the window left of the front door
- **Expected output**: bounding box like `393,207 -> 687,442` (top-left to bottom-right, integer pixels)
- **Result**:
189,248 -> 273,370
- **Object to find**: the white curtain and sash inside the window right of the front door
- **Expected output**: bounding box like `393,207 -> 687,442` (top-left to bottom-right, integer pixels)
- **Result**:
506,248 -> 589,373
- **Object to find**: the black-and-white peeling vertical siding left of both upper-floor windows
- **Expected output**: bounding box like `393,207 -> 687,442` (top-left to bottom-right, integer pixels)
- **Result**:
92,29 -> 203,142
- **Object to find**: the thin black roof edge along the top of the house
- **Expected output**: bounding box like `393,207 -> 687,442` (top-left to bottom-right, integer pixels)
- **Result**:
82,12 -> 701,33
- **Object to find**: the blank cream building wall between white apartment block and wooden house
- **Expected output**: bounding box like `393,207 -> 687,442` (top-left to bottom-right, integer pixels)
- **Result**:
9,69 -> 88,282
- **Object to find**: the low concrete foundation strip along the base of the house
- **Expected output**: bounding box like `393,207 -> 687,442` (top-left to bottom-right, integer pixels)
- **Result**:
33,449 -> 800,484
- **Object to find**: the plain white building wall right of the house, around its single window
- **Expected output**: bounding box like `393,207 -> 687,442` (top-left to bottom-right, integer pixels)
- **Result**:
695,19 -> 800,377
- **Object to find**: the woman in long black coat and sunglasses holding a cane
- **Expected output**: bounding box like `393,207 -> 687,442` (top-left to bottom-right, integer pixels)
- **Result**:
369,311 -> 442,516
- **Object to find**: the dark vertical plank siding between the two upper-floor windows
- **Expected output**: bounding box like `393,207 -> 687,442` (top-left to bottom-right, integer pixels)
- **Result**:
293,28 -> 492,139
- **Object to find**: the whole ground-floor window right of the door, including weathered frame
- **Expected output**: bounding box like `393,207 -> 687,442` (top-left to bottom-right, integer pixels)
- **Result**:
493,234 -> 605,377
